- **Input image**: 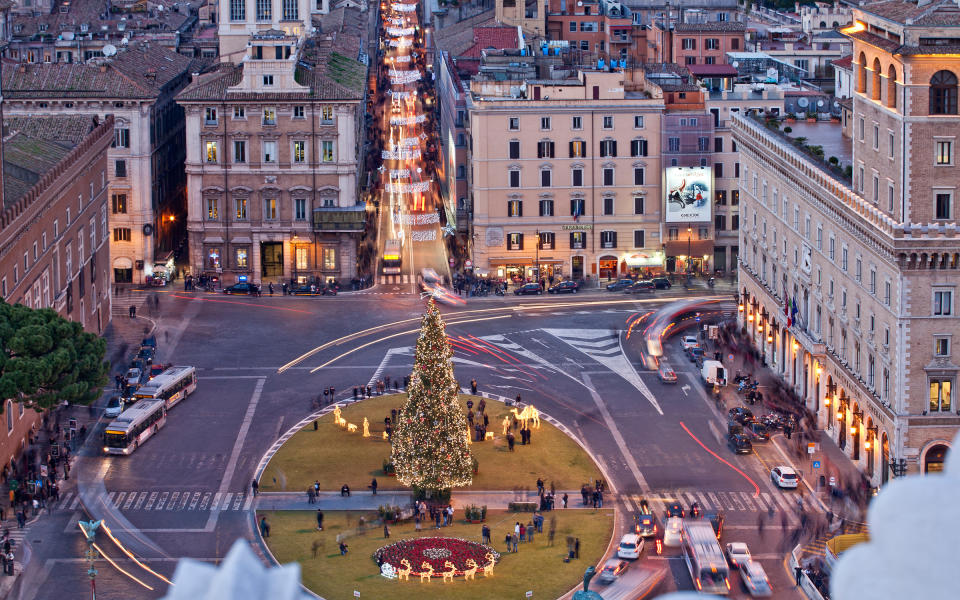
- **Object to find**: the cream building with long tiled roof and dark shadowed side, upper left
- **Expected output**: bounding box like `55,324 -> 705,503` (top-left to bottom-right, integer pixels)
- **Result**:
2,42 -> 194,283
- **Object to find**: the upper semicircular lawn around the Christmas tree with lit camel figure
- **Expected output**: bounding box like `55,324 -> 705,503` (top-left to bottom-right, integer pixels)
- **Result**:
260,394 -> 602,492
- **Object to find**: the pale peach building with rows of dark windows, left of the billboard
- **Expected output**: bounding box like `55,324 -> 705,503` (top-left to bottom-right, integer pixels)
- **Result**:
468,69 -> 664,282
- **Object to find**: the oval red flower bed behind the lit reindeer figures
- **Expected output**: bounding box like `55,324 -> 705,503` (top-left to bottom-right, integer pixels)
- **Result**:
373,537 -> 500,577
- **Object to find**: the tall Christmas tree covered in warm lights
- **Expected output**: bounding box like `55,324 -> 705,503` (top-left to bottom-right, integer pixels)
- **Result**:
392,300 -> 473,492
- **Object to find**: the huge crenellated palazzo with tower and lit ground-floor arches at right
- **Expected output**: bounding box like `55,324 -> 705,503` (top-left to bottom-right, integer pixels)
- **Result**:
732,0 -> 960,485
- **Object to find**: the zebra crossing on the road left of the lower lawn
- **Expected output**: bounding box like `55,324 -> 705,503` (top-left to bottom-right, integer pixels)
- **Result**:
52,491 -> 253,512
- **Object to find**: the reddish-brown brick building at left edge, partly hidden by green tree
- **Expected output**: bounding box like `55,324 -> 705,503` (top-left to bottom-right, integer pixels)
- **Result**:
0,115 -> 114,472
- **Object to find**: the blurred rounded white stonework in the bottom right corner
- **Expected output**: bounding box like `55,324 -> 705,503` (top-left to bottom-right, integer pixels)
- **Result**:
830,434 -> 960,600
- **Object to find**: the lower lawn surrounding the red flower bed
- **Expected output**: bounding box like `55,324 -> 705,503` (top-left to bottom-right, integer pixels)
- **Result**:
257,509 -> 613,600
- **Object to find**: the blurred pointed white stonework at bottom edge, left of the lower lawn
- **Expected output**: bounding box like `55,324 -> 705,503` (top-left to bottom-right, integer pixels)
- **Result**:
164,540 -> 303,600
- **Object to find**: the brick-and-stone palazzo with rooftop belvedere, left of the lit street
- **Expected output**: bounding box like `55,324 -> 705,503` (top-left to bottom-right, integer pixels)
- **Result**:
177,5 -> 367,285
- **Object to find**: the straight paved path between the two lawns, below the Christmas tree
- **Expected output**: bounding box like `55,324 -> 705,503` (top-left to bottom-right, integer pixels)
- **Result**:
254,490 -> 592,510
